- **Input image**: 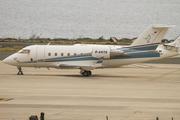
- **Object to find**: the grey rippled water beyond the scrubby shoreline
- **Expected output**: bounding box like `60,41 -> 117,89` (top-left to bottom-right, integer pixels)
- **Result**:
0,0 -> 180,39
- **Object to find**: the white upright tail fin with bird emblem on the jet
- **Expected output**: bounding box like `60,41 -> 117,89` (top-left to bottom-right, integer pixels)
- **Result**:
130,24 -> 173,46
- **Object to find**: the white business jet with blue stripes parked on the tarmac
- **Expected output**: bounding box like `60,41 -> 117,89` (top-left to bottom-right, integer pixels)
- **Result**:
3,24 -> 180,77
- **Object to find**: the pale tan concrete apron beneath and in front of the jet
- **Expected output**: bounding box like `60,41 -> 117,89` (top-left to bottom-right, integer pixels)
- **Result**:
0,62 -> 180,120
